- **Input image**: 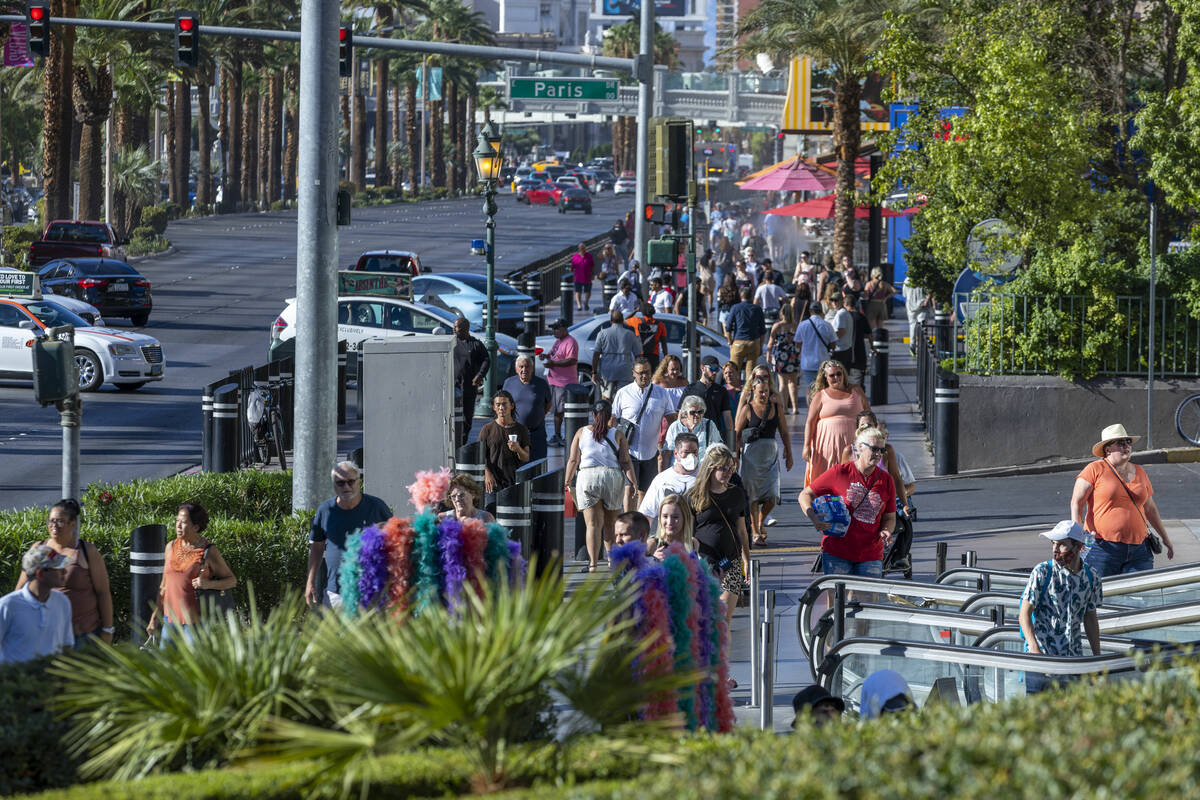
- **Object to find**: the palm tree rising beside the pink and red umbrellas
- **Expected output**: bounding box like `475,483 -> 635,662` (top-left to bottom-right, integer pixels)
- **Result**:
728,0 -> 895,263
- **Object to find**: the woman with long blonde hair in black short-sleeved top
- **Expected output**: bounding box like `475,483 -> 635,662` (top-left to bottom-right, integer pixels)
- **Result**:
686,445 -> 750,620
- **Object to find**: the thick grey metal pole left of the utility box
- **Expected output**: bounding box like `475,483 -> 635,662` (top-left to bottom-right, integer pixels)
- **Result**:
292,0 -> 340,511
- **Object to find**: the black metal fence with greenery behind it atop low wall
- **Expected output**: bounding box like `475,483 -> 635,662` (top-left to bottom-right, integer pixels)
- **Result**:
955,293 -> 1200,377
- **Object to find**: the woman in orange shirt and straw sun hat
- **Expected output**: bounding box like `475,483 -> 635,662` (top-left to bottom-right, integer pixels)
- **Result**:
1070,425 -> 1175,578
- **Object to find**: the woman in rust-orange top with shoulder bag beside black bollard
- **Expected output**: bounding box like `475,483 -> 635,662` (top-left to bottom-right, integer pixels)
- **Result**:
146,503 -> 238,644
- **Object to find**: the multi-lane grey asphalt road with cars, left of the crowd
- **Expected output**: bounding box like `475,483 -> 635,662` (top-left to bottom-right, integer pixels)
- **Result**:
0,194 -> 632,509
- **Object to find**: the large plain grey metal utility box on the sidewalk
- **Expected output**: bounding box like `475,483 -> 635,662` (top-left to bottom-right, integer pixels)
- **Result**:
361,336 -> 455,517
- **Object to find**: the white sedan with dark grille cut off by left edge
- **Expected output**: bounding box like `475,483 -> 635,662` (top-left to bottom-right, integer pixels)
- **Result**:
0,297 -> 167,392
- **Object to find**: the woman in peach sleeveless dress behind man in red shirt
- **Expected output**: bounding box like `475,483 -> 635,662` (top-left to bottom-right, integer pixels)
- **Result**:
804,360 -> 870,486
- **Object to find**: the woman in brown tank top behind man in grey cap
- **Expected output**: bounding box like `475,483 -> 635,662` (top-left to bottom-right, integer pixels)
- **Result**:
17,498 -> 114,648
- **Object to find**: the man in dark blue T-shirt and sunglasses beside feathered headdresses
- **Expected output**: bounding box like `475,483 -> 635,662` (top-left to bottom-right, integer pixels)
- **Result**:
305,461 -> 391,607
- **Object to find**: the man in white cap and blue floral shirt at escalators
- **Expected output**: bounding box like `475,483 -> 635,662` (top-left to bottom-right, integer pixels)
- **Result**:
1020,519 -> 1103,692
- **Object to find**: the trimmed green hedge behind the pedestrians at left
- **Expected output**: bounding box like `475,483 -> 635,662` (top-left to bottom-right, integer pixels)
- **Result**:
0,470 -> 312,638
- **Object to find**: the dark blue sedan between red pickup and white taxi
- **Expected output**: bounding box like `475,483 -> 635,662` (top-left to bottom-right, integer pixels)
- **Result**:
37,258 -> 154,326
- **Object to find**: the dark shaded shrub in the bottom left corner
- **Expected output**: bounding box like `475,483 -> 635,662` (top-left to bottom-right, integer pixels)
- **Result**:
0,658 -> 78,796
